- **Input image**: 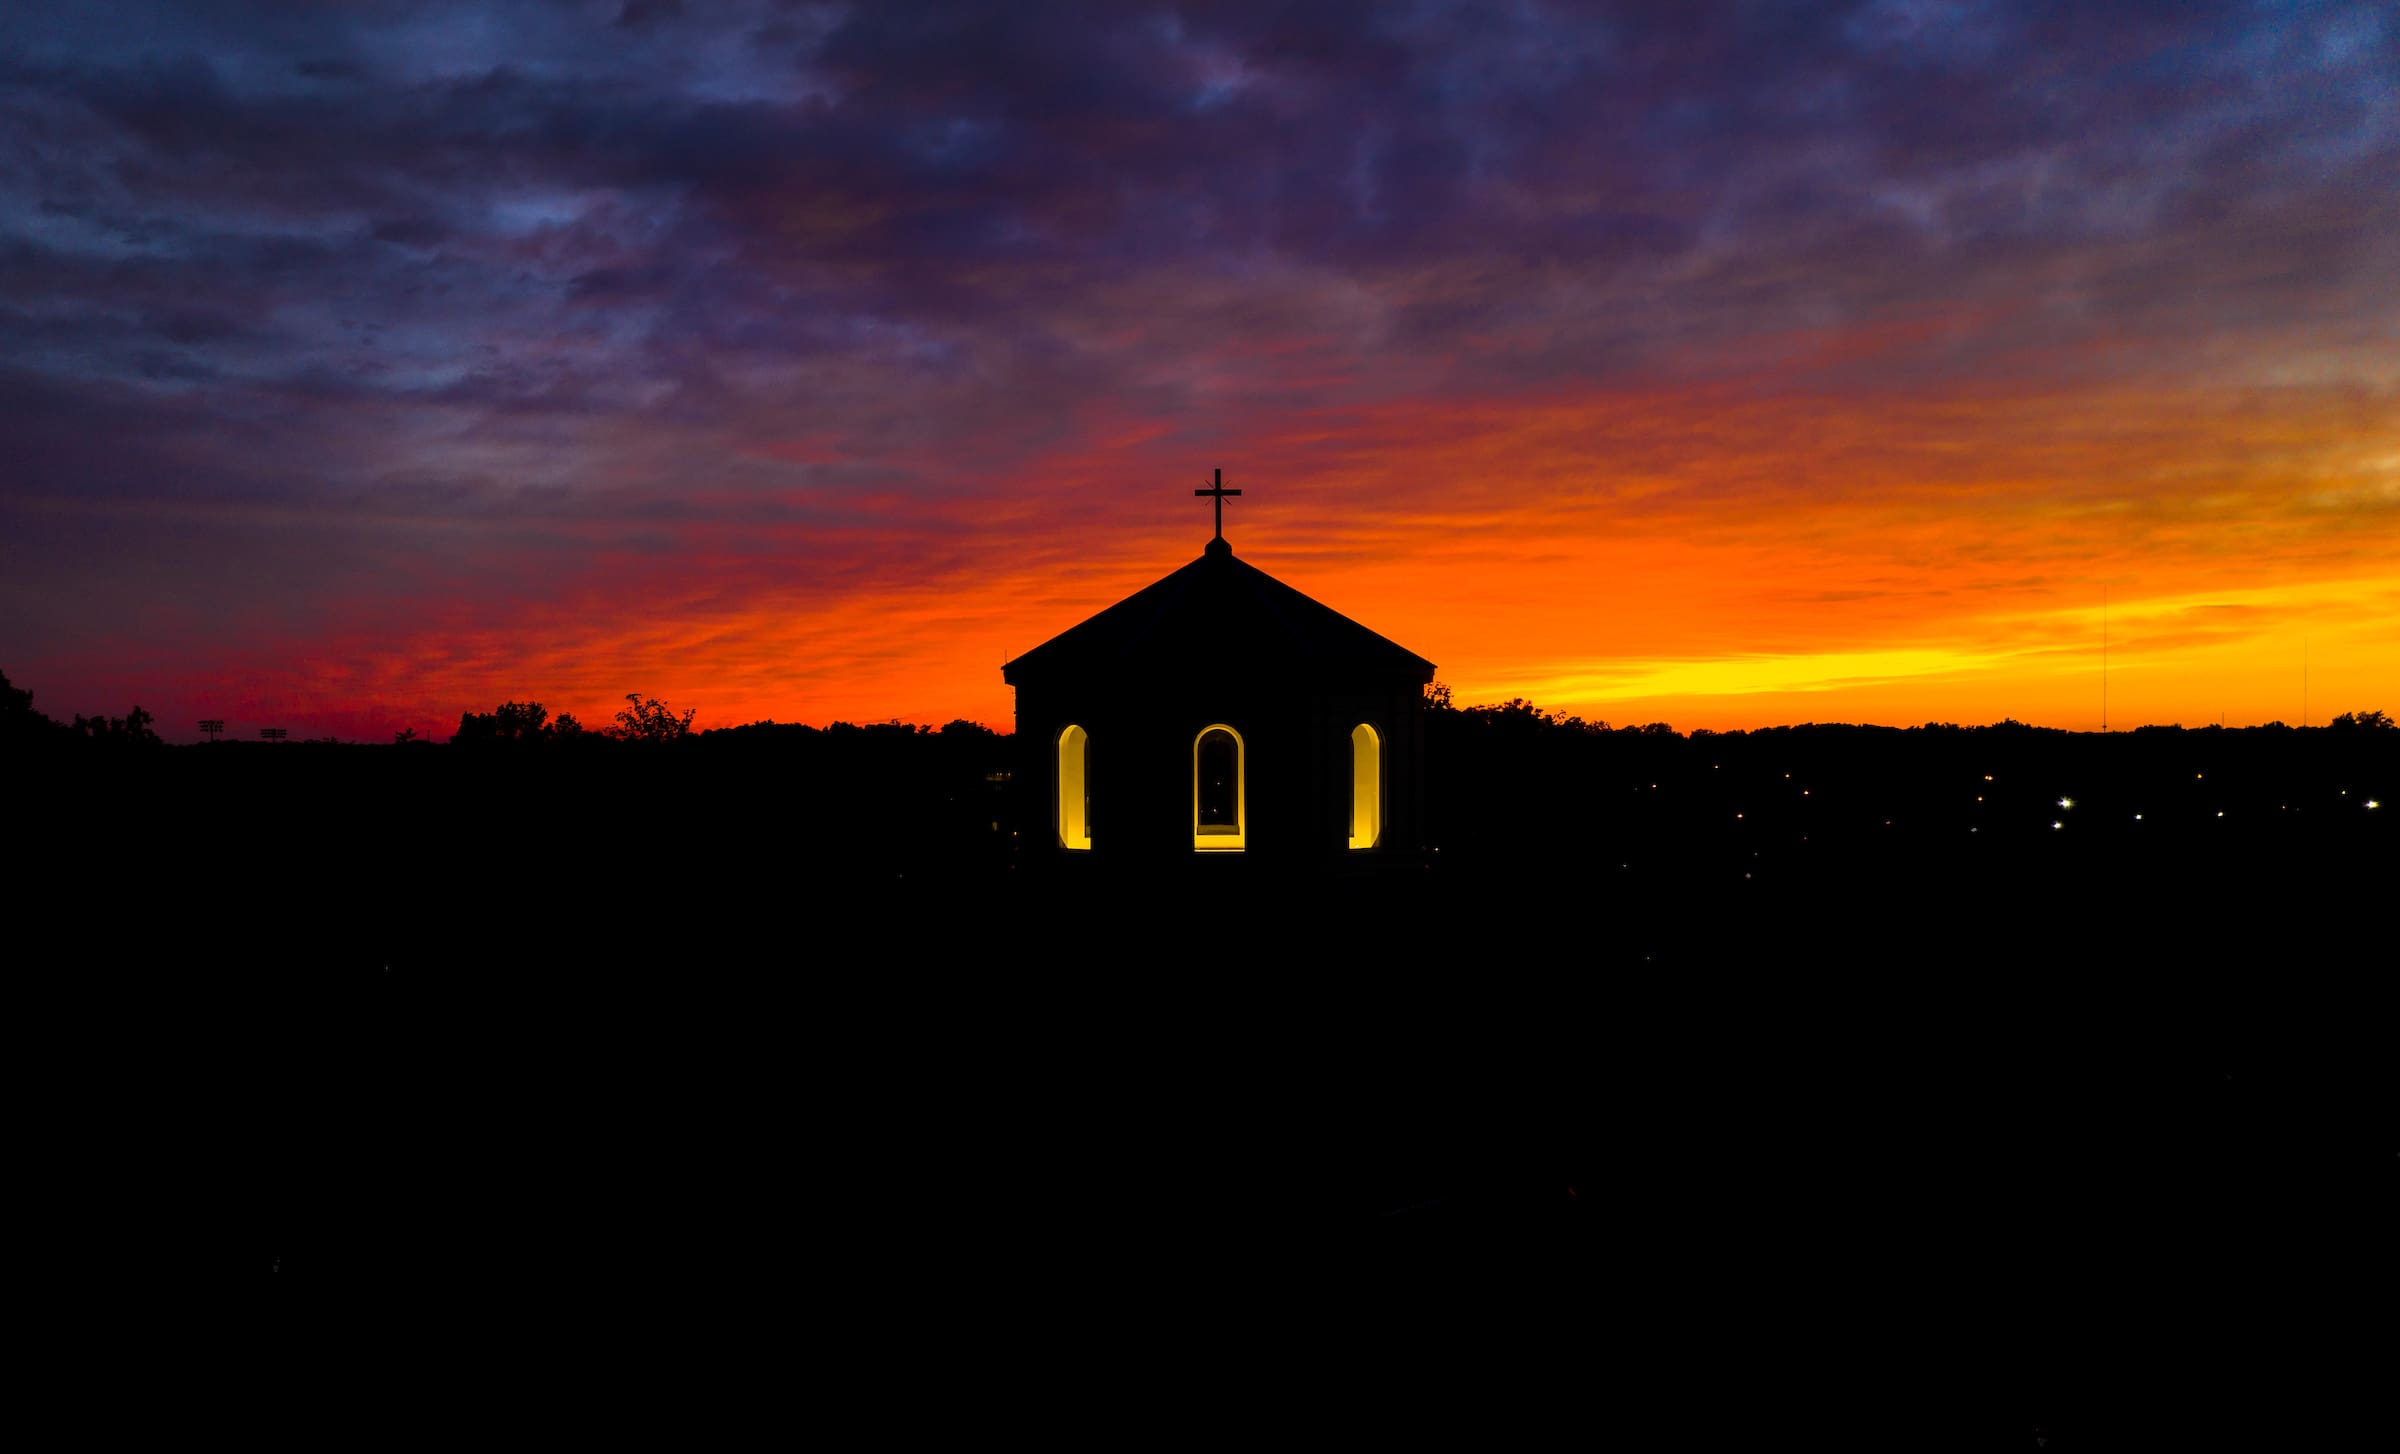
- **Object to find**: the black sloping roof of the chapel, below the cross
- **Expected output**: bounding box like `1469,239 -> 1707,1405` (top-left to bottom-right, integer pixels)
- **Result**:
1001,540 -> 1433,686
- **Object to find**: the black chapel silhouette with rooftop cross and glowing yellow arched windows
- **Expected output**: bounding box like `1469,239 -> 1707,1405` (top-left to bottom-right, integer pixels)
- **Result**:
1001,470 -> 1433,864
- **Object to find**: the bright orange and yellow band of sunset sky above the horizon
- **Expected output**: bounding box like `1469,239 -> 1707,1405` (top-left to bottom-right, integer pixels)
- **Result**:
65,369 -> 2400,737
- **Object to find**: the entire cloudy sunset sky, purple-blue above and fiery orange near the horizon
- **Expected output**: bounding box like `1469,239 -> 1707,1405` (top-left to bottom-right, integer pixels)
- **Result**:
0,0 -> 2400,741
